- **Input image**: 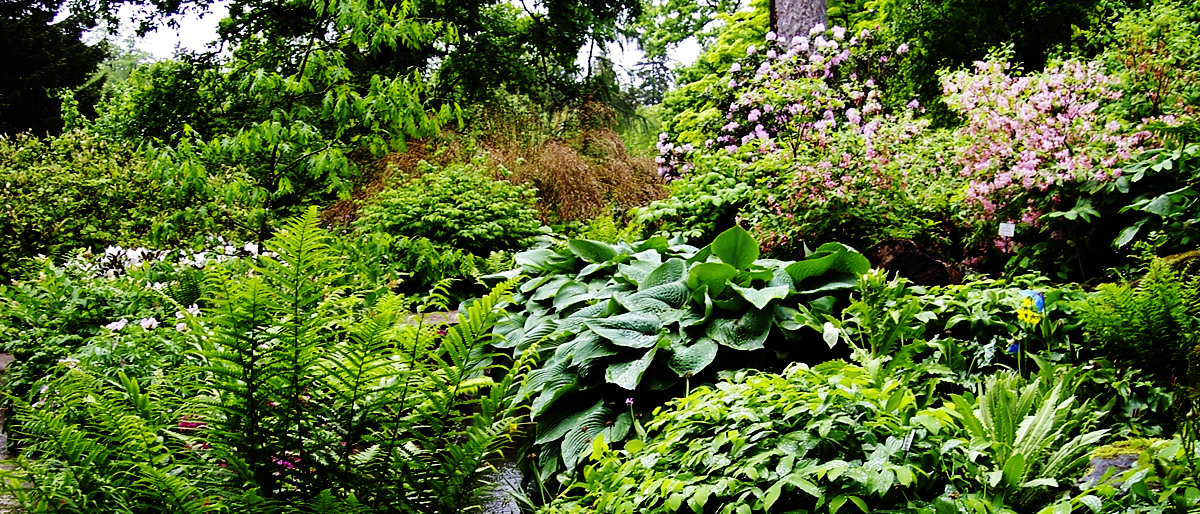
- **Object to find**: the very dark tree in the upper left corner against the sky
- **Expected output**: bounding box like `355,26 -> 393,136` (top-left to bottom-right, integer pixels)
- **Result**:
0,0 -> 108,135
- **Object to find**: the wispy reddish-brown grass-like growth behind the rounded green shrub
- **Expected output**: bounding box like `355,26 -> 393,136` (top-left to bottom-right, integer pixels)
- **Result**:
322,100 -> 667,226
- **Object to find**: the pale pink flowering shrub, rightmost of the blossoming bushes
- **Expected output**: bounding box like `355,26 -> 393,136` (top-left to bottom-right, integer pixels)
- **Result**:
943,56 -> 1150,272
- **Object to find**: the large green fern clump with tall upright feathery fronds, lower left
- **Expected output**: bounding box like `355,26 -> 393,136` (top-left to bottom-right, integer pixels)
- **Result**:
4,209 -> 528,513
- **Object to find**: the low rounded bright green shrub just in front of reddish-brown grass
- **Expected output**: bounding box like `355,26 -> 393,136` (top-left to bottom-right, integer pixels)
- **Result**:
354,165 -> 540,256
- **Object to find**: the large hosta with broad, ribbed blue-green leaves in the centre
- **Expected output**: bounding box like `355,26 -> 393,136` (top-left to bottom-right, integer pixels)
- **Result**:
482,227 -> 870,480
